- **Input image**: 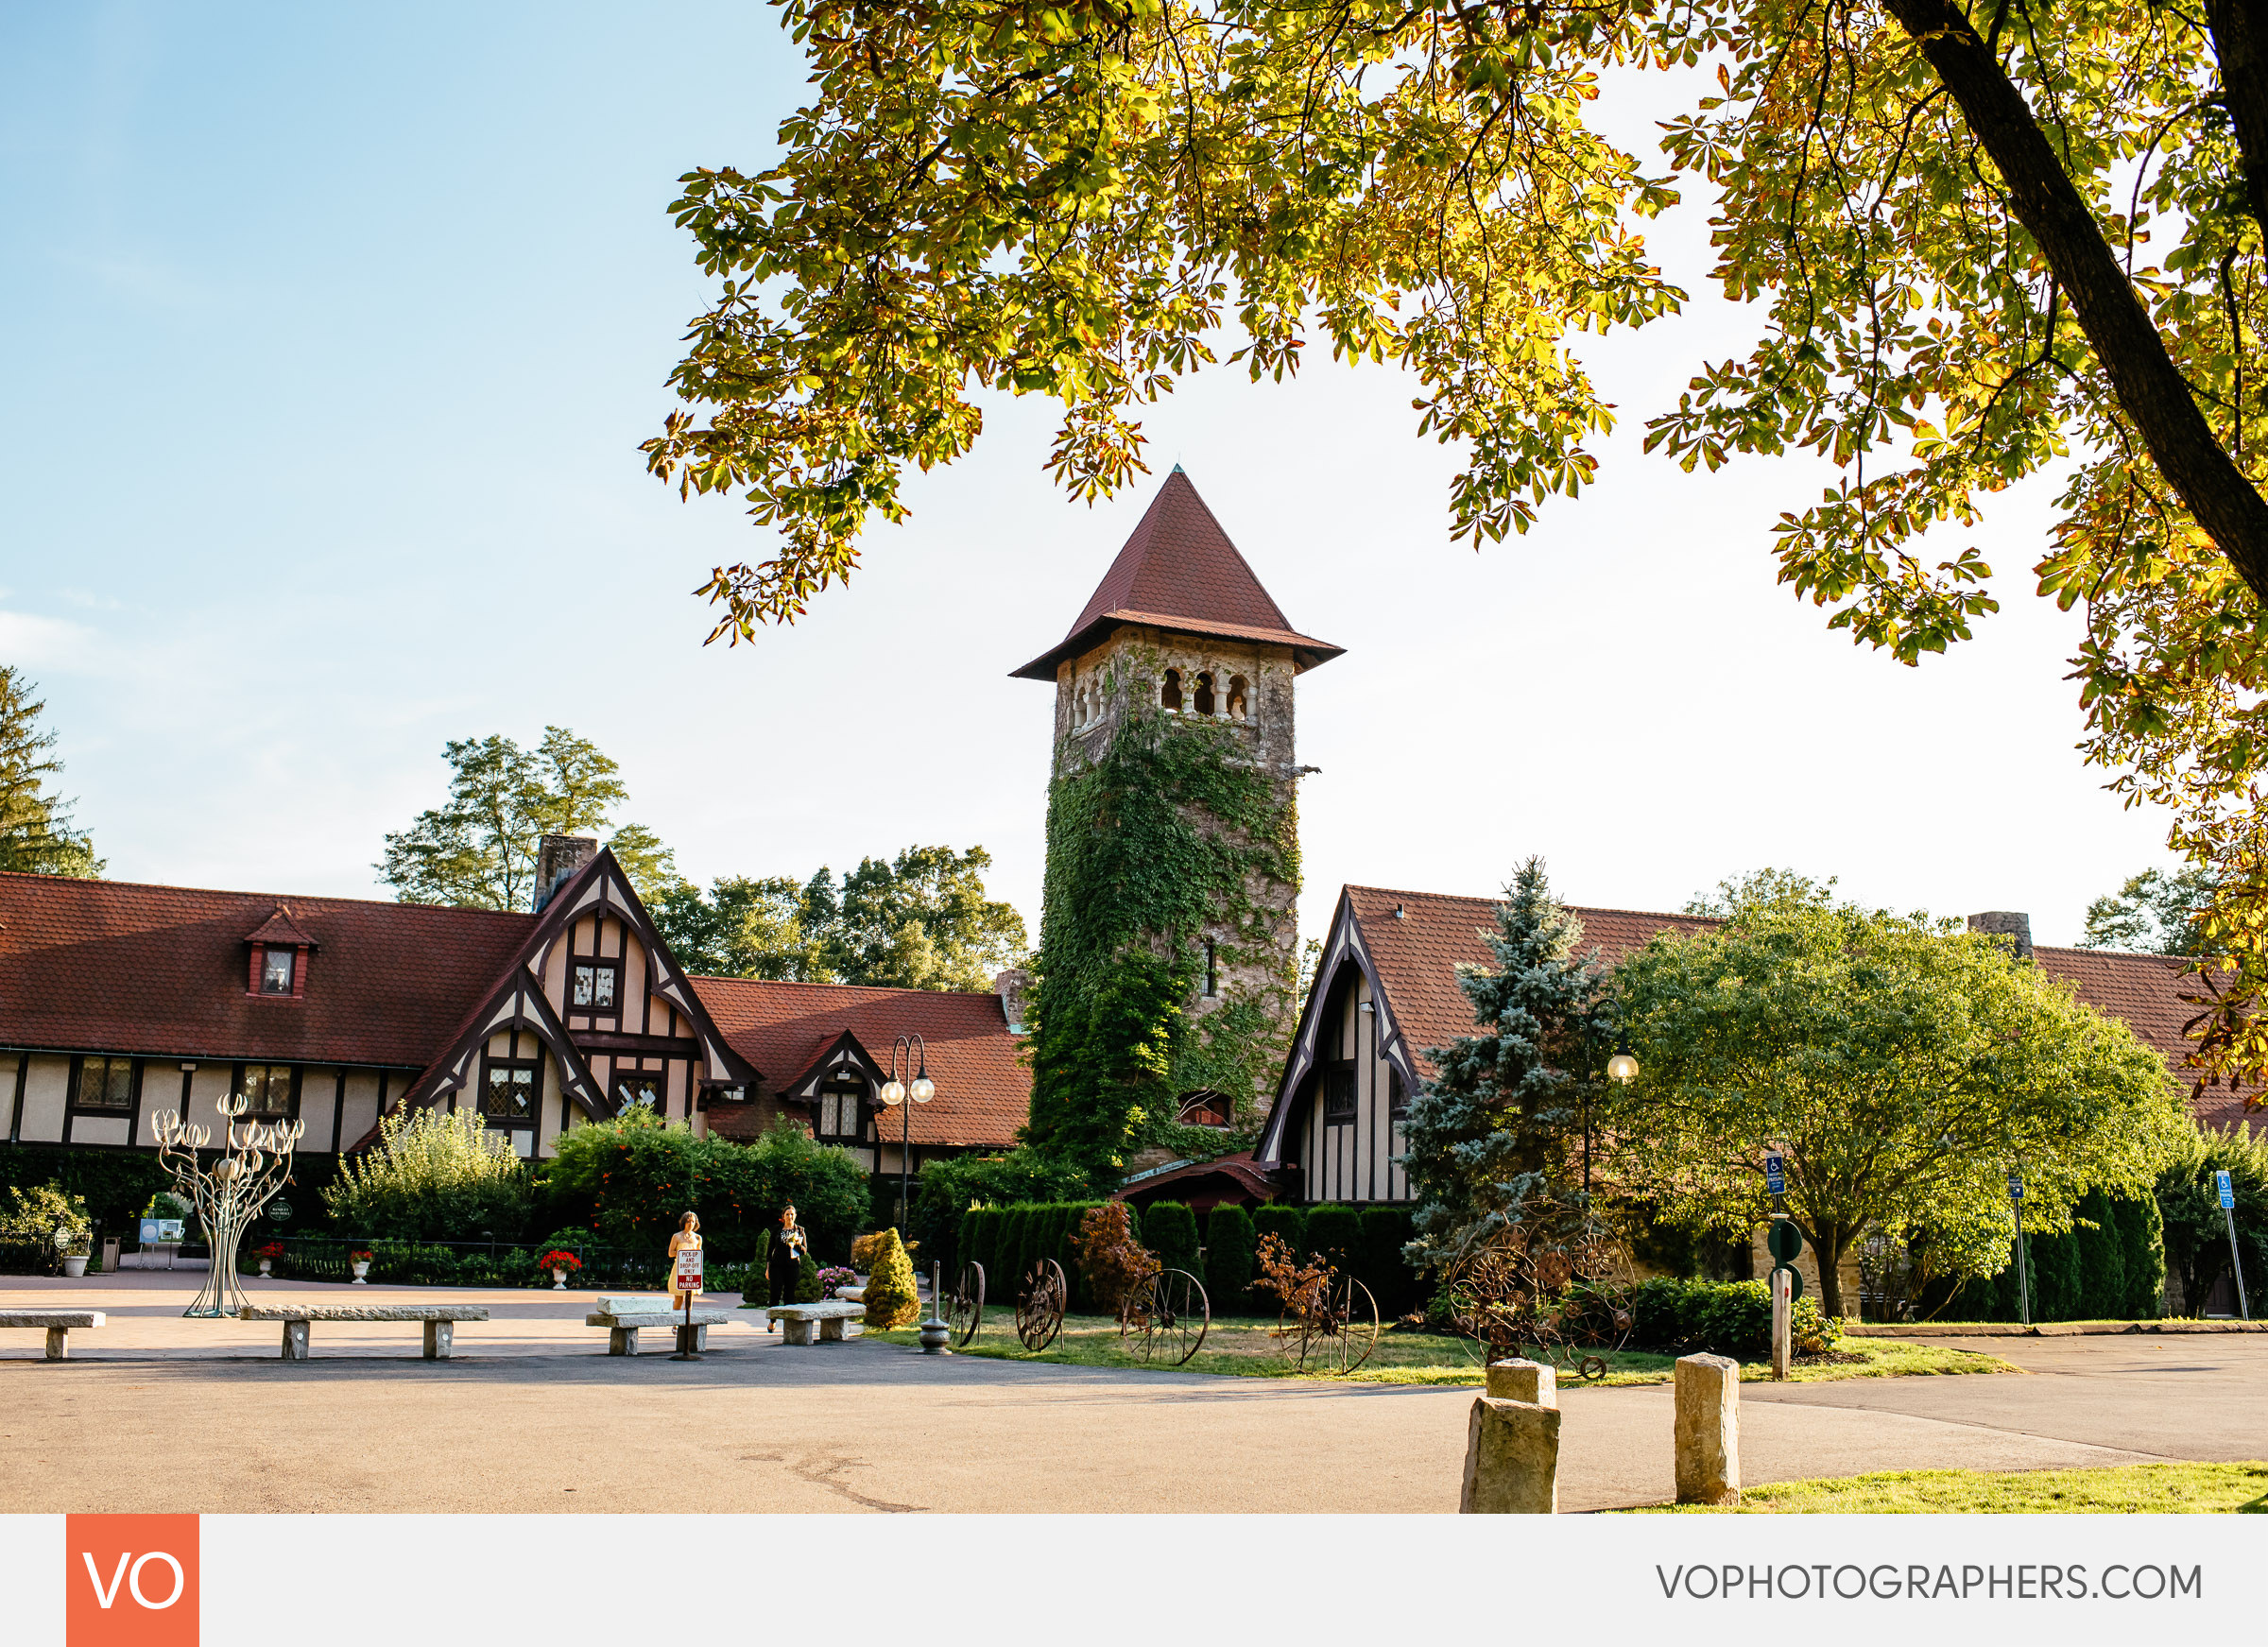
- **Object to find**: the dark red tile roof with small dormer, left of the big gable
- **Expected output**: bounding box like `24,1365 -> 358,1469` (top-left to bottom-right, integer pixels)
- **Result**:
0,873 -> 535,1069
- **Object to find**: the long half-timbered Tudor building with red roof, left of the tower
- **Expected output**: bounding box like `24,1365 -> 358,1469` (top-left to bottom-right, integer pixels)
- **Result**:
0,837 -> 1030,1173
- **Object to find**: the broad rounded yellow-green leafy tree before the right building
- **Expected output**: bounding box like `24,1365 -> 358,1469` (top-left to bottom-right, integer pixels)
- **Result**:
1610,881 -> 2187,1315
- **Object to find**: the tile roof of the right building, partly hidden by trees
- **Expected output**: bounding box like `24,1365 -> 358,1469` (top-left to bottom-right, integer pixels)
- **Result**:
1348,887 -> 2259,1125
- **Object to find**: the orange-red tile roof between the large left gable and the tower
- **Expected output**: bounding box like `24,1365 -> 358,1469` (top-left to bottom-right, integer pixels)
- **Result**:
692,978 -> 1032,1148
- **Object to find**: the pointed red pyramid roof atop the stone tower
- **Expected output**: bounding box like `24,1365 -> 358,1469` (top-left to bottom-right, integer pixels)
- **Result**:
1011,463 -> 1345,680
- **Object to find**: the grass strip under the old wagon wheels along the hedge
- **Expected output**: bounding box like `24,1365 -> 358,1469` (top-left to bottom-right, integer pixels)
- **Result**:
864,1307 -> 2019,1388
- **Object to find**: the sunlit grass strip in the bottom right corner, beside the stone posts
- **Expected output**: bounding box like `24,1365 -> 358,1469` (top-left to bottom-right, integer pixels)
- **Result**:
1626,1464 -> 2268,1516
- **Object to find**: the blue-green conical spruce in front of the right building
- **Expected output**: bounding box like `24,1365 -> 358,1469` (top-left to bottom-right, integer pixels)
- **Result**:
1406,858 -> 1599,1263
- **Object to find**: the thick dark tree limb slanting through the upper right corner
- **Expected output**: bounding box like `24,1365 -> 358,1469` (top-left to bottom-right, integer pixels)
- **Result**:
1878,0 -> 2268,608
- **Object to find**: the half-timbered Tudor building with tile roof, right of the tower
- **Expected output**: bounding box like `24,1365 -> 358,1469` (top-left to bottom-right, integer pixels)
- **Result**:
1251,887 -> 2245,1205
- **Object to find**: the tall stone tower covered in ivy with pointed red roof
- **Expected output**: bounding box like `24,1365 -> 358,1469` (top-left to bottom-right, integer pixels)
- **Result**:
1014,465 -> 1340,1179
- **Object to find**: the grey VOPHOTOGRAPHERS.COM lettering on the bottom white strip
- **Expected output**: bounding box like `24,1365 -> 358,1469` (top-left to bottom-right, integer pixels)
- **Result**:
1654,1561 -> 2205,1602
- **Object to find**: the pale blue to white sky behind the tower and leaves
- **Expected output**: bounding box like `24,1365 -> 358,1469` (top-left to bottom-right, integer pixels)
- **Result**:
0,5 -> 2164,941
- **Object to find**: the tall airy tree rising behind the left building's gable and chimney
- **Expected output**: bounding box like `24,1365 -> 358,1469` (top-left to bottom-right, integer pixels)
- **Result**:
374,726 -> 682,910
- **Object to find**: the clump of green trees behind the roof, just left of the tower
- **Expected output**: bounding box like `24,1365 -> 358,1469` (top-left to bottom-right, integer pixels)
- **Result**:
653,847 -> 1025,989
